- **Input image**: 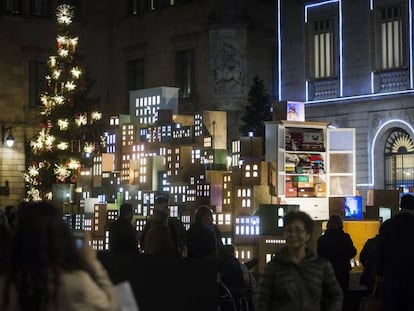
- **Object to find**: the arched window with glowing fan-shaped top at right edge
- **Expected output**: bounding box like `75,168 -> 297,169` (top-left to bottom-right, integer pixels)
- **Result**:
384,129 -> 414,192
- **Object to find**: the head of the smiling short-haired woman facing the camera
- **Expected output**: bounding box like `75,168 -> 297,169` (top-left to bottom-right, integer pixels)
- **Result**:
283,211 -> 313,248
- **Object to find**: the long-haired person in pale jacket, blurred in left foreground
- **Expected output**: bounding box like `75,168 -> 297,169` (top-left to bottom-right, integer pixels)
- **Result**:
0,202 -> 121,311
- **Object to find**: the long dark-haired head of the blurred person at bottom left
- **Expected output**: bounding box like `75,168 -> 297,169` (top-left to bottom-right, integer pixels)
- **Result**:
0,202 -> 93,310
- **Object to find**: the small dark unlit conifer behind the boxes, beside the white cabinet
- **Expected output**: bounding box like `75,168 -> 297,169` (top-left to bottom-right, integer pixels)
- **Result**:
239,76 -> 272,137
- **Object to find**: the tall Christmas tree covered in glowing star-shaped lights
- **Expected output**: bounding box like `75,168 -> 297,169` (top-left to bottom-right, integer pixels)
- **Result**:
24,4 -> 102,201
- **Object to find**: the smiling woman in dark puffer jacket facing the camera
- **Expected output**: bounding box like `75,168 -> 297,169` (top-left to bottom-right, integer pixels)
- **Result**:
256,211 -> 343,311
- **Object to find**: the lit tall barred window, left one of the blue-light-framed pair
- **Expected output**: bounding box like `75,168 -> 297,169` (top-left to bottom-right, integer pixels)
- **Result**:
312,20 -> 334,79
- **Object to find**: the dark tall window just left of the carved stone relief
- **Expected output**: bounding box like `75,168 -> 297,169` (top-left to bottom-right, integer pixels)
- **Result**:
175,49 -> 195,98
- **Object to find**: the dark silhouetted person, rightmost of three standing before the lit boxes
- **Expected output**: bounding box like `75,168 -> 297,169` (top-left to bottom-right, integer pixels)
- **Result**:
187,206 -> 223,259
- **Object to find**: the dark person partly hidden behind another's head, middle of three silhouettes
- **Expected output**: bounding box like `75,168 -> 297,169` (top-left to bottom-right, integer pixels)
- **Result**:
140,196 -> 187,257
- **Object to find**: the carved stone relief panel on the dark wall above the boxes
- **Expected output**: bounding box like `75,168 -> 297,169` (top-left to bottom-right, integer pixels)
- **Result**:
211,30 -> 245,95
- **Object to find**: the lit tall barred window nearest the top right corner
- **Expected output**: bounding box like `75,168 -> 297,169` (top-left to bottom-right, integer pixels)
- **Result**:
380,7 -> 403,69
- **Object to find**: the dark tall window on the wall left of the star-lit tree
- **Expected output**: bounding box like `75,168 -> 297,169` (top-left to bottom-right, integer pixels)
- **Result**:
29,61 -> 47,107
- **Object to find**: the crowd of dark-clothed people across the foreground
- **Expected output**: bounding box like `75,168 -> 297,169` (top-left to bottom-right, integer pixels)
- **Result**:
0,194 -> 414,311
